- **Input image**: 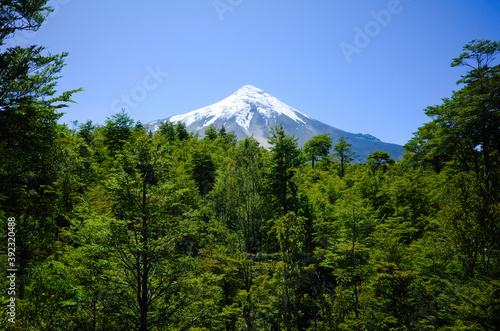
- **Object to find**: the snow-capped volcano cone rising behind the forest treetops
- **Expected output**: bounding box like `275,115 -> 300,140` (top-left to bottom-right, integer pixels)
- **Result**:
147,85 -> 403,161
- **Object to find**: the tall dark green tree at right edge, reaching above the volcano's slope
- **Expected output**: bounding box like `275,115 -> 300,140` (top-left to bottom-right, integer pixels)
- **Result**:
406,40 -> 500,196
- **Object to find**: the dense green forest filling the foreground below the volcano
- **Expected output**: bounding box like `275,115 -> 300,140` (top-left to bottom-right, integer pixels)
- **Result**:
0,0 -> 500,331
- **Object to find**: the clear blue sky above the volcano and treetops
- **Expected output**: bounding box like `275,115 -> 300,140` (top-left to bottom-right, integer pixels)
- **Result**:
7,0 -> 500,144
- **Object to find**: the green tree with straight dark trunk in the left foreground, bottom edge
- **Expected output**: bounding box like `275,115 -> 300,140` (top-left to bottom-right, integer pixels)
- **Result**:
102,132 -> 212,330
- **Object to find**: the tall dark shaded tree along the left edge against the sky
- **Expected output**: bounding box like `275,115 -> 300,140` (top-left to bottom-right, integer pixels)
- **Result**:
0,0 -> 77,298
